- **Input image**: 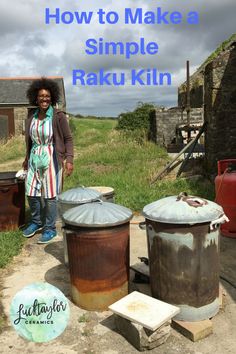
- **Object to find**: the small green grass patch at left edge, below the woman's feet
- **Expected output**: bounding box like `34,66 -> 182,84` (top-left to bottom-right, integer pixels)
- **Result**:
0,231 -> 24,268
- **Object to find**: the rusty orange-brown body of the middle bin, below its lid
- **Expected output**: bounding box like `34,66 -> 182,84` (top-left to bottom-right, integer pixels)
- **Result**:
65,222 -> 129,311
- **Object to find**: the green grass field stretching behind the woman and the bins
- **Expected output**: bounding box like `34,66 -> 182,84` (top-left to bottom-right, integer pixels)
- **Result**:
0,119 -> 214,267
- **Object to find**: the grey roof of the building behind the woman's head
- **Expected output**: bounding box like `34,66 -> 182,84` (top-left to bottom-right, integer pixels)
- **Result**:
0,76 -> 66,106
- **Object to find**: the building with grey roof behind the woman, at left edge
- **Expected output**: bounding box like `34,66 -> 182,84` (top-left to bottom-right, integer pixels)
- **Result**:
0,77 -> 66,139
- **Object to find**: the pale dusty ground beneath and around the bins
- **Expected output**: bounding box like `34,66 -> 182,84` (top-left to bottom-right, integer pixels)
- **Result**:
0,218 -> 236,354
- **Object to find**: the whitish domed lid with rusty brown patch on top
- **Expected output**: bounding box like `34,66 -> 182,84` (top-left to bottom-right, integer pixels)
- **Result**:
142,193 -> 224,225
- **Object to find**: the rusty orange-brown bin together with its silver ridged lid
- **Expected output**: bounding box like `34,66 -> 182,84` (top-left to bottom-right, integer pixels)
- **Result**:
63,202 -> 132,311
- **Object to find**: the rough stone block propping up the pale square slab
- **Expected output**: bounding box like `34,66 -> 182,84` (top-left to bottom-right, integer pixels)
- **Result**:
115,315 -> 170,351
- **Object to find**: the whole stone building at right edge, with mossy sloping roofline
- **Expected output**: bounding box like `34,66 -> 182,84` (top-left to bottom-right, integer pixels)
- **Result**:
178,34 -> 236,174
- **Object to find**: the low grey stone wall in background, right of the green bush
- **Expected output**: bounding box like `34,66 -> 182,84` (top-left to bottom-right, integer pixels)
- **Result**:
151,107 -> 203,147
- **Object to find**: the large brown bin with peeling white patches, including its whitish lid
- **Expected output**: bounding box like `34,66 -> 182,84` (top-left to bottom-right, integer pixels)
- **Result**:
143,193 -> 227,321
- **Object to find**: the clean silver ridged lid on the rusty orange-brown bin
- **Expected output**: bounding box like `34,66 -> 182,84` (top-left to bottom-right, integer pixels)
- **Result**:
62,202 -> 133,227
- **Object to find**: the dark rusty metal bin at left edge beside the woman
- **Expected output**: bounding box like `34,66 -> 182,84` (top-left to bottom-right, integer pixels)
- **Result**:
0,171 -> 25,231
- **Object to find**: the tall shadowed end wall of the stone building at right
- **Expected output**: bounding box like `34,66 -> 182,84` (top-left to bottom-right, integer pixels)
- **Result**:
204,43 -> 236,174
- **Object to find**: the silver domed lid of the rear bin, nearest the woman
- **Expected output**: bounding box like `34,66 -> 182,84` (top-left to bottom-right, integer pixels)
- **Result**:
58,187 -> 102,204
